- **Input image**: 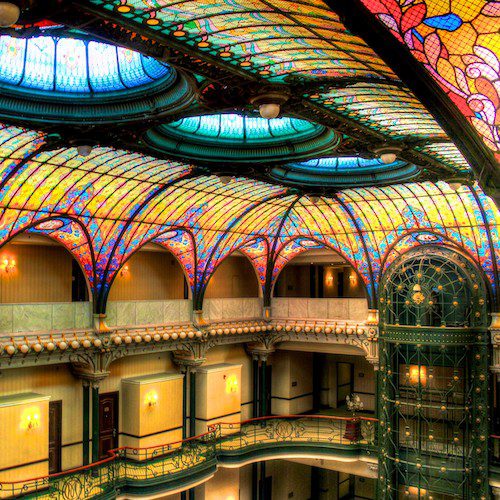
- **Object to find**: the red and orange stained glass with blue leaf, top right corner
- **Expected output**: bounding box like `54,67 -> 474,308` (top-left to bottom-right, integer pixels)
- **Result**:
362,0 -> 500,161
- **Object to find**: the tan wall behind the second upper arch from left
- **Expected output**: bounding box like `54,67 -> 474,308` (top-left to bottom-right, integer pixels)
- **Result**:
109,251 -> 184,301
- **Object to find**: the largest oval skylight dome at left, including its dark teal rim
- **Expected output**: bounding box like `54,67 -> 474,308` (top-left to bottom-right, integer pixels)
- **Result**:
0,31 -> 195,125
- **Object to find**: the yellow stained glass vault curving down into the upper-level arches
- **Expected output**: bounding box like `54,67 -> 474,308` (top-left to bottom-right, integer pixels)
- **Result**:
0,125 -> 500,308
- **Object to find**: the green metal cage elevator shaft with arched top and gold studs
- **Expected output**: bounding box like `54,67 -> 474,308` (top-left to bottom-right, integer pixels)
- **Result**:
378,245 -> 489,500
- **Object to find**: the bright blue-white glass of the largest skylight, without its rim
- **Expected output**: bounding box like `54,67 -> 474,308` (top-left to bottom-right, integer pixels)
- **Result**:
0,35 -> 172,97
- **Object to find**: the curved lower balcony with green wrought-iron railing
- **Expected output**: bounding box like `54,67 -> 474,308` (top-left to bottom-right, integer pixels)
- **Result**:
0,415 -> 377,500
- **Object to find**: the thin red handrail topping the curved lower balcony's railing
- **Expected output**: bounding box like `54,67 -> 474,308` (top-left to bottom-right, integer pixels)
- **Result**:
0,415 -> 378,494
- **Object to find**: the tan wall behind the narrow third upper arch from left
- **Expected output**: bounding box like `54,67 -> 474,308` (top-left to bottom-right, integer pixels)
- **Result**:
205,256 -> 259,299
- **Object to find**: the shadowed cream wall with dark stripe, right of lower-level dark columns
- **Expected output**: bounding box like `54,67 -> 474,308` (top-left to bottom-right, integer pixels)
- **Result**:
270,350 -> 313,415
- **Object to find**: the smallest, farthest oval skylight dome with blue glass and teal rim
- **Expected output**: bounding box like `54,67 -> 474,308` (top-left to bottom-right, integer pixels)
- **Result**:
271,156 -> 420,188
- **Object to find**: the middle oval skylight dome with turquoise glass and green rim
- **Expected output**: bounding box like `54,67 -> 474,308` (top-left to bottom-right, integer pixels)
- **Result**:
144,113 -> 340,162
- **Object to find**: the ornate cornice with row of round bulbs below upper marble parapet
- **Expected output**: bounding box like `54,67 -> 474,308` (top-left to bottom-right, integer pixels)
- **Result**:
0,318 -> 378,368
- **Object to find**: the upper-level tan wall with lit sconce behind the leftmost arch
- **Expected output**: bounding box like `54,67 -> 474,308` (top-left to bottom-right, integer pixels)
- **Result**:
0,243 -> 71,304
